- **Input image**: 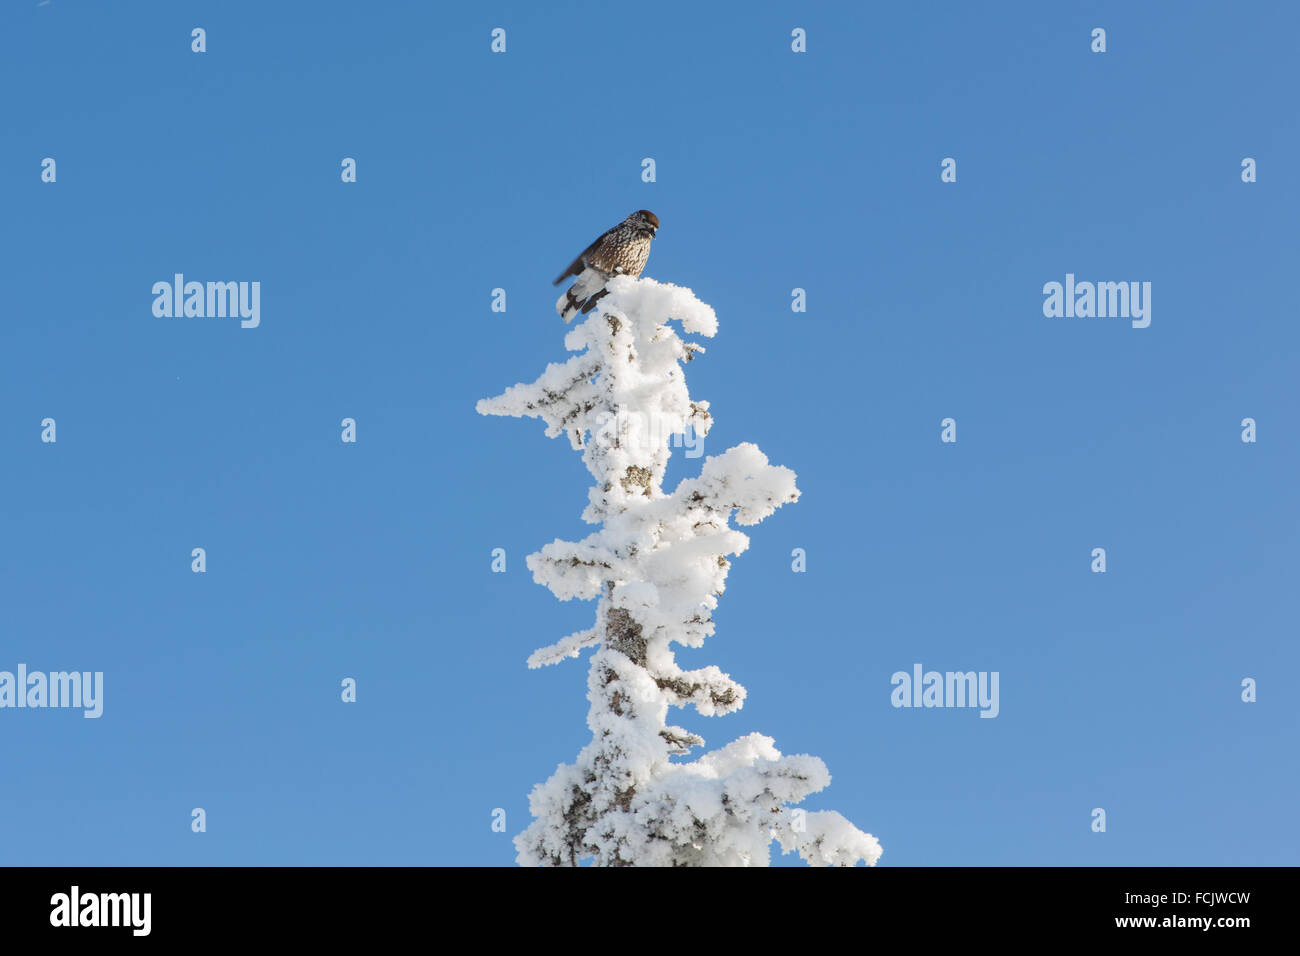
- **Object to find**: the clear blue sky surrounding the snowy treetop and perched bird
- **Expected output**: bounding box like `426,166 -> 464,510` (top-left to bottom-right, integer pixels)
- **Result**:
0,0 -> 1300,865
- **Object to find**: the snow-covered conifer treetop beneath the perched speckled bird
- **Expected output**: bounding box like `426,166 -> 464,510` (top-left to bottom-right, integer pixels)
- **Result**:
477,277 -> 880,866
